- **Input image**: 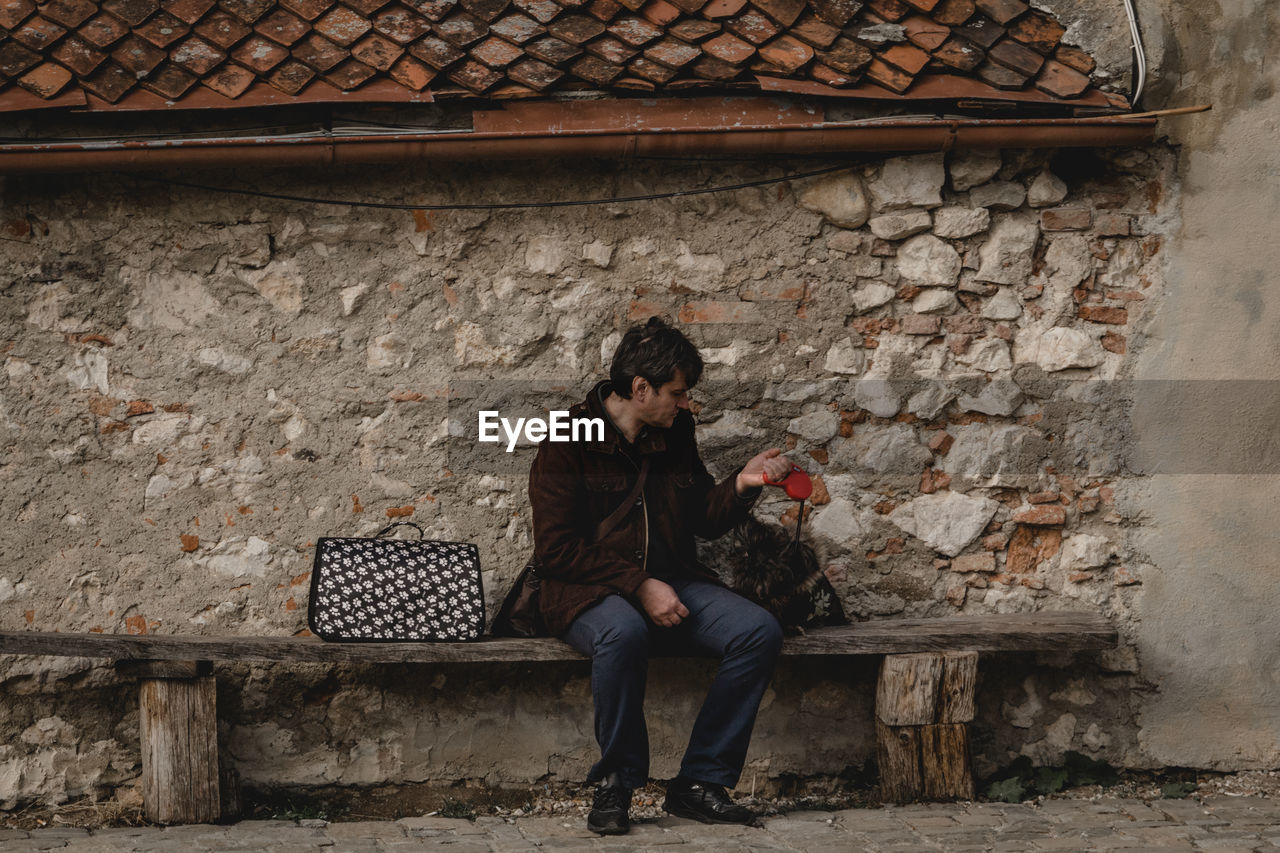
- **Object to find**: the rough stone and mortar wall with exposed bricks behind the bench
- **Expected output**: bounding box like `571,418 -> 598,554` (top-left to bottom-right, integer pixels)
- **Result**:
0,140 -> 1178,806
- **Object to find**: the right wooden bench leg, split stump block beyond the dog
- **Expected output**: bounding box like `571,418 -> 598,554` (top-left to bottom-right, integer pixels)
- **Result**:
876,652 -> 978,803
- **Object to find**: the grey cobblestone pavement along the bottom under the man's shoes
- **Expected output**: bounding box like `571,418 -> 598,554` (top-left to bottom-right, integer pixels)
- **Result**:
0,795 -> 1280,853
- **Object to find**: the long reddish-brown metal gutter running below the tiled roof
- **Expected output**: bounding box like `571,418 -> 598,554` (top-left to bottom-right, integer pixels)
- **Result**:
0,117 -> 1156,174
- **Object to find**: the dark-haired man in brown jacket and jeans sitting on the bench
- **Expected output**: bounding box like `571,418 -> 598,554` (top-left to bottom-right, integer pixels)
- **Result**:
529,318 -> 791,835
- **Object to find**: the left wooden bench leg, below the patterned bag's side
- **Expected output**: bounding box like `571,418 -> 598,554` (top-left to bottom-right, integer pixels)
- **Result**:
120,661 -> 220,824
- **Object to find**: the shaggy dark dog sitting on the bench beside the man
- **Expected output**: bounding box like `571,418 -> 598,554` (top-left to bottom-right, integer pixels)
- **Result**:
728,517 -> 849,634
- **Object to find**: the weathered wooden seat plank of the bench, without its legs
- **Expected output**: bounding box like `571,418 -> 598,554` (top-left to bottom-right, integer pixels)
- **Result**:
0,611 -> 1117,663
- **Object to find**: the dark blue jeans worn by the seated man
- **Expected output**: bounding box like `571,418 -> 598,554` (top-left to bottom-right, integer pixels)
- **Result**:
562,579 -> 782,789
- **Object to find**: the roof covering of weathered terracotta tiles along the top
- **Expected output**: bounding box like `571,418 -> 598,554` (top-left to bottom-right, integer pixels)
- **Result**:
0,0 -> 1123,109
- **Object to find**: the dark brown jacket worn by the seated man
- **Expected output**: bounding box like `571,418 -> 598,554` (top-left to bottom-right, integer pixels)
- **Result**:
529,382 -> 758,635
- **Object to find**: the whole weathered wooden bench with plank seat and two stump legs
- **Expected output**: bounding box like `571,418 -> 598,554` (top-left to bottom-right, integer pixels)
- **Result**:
0,612 -> 1116,824
